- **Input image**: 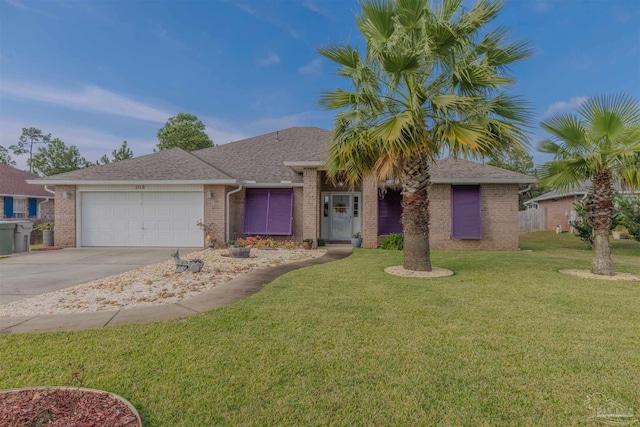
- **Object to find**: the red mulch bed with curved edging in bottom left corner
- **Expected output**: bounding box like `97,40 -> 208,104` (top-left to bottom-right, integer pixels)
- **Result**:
0,388 -> 140,427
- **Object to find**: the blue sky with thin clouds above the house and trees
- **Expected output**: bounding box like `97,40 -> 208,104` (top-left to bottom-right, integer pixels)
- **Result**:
0,0 -> 640,171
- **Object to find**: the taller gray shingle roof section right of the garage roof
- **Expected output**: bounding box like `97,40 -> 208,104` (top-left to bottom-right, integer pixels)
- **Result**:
193,127 -> 330,183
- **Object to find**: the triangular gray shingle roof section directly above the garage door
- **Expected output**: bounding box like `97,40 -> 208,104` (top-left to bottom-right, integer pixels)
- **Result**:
32,148 -> 233,182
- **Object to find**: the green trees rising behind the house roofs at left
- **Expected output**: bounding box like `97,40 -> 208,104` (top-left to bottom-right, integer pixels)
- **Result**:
0,113 -> 214,176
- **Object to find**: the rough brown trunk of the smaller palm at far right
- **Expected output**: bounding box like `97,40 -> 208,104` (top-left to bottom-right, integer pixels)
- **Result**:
586,171 -> 615,276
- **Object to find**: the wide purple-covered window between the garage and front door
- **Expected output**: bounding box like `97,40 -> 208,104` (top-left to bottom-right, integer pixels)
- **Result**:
242,188 -> 293,235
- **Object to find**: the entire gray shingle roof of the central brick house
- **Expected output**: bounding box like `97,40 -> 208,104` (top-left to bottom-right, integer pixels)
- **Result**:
32,127 -> 535,184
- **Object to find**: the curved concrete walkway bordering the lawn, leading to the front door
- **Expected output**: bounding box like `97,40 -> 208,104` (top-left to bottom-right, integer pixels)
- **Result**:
0,248 -> 351,334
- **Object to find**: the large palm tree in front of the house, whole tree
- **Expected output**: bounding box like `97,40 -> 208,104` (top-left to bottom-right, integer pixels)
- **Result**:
319,0 -> 532,271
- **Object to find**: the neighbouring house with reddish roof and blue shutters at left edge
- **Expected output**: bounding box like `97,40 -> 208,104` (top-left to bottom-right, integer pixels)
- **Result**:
0,164 -> 54,221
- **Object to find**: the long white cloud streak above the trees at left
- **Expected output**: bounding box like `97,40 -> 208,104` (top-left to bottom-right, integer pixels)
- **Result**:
0,81 -> 173,123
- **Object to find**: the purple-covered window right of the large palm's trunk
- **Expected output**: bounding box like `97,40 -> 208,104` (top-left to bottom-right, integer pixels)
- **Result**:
451,185 -> 482,239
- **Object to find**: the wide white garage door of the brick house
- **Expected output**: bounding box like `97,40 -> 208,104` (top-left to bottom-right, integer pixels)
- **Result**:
81,192 -> 203,248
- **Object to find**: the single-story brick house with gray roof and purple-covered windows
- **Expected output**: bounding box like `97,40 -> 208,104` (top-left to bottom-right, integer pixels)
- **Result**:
33,128 -> 535,249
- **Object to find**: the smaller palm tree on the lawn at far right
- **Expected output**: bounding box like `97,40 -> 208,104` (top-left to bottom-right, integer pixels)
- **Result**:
539,95 -> 640,276
